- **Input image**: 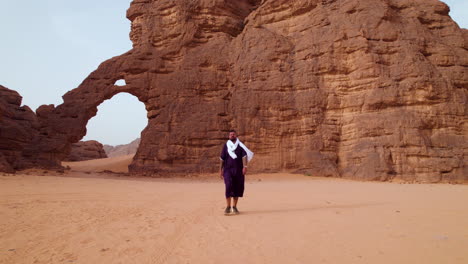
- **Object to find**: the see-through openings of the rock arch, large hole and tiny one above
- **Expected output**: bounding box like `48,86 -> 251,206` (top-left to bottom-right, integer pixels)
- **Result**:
65,92 -> 148,172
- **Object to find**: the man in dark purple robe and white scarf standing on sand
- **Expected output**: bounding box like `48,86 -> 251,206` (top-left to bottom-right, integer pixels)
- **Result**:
220,130 -> 253,215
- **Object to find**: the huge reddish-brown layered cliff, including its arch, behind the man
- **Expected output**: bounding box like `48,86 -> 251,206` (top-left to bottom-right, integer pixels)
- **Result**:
12,0 -> 468,182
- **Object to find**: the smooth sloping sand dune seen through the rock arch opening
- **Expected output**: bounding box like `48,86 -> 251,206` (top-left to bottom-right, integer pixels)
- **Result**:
62,154 -> 134,172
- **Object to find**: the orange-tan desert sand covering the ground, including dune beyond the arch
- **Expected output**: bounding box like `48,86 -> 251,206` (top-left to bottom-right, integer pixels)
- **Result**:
0,156 -> 468,264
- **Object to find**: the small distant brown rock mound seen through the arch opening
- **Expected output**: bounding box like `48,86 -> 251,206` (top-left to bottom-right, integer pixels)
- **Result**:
65,140 -> 107,161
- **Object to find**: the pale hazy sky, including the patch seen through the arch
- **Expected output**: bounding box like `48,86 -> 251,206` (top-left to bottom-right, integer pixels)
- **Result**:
0,0 -> 468,145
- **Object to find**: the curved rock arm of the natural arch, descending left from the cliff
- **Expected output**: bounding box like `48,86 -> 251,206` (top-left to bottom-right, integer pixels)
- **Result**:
23,52 -> 149,167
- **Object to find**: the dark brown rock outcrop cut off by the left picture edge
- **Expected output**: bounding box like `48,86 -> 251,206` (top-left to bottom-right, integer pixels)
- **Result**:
0,85 -> 38,173
